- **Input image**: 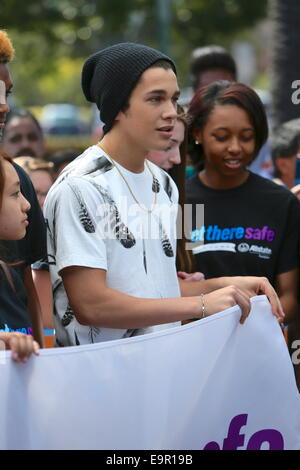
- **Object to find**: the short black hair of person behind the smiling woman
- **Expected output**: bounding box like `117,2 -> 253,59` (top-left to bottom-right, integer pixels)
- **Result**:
190,45 -> 237,90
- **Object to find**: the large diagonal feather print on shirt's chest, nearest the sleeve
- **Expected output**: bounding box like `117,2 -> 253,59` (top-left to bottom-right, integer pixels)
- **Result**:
85,180 -> 136,248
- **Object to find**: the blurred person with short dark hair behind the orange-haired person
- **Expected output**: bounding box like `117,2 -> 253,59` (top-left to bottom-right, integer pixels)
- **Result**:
2,109 -> 46,158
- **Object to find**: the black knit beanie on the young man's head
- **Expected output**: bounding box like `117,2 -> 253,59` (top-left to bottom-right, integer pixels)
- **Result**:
81,42 -> 176,133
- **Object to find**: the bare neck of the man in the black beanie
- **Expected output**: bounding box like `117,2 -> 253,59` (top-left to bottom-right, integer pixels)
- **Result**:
98,132 -> 147,173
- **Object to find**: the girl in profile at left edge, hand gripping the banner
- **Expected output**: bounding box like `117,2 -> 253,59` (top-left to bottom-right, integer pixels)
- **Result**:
0,154 -> 39,362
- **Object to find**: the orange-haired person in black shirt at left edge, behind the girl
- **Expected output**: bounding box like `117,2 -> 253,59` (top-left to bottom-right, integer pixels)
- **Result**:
0,30 -> 47,346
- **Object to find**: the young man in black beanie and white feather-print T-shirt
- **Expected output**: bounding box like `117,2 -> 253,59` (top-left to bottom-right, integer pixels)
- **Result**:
45,43 -> 283,346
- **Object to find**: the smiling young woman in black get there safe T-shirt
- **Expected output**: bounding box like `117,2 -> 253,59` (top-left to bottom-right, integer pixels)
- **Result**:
187,82 -> 300,322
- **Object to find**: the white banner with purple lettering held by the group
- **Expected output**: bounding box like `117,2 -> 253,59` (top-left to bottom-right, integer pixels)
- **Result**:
0,296 -> 300,450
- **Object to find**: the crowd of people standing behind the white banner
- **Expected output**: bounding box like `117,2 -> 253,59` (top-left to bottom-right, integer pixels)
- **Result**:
0,27 -> 300,392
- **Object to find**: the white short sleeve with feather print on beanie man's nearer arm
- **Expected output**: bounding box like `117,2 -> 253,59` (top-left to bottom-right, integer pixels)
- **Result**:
45,178 -> 107,272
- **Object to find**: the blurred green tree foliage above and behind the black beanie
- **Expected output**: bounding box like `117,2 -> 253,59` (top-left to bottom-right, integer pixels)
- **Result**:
0,0 -> 267,104
